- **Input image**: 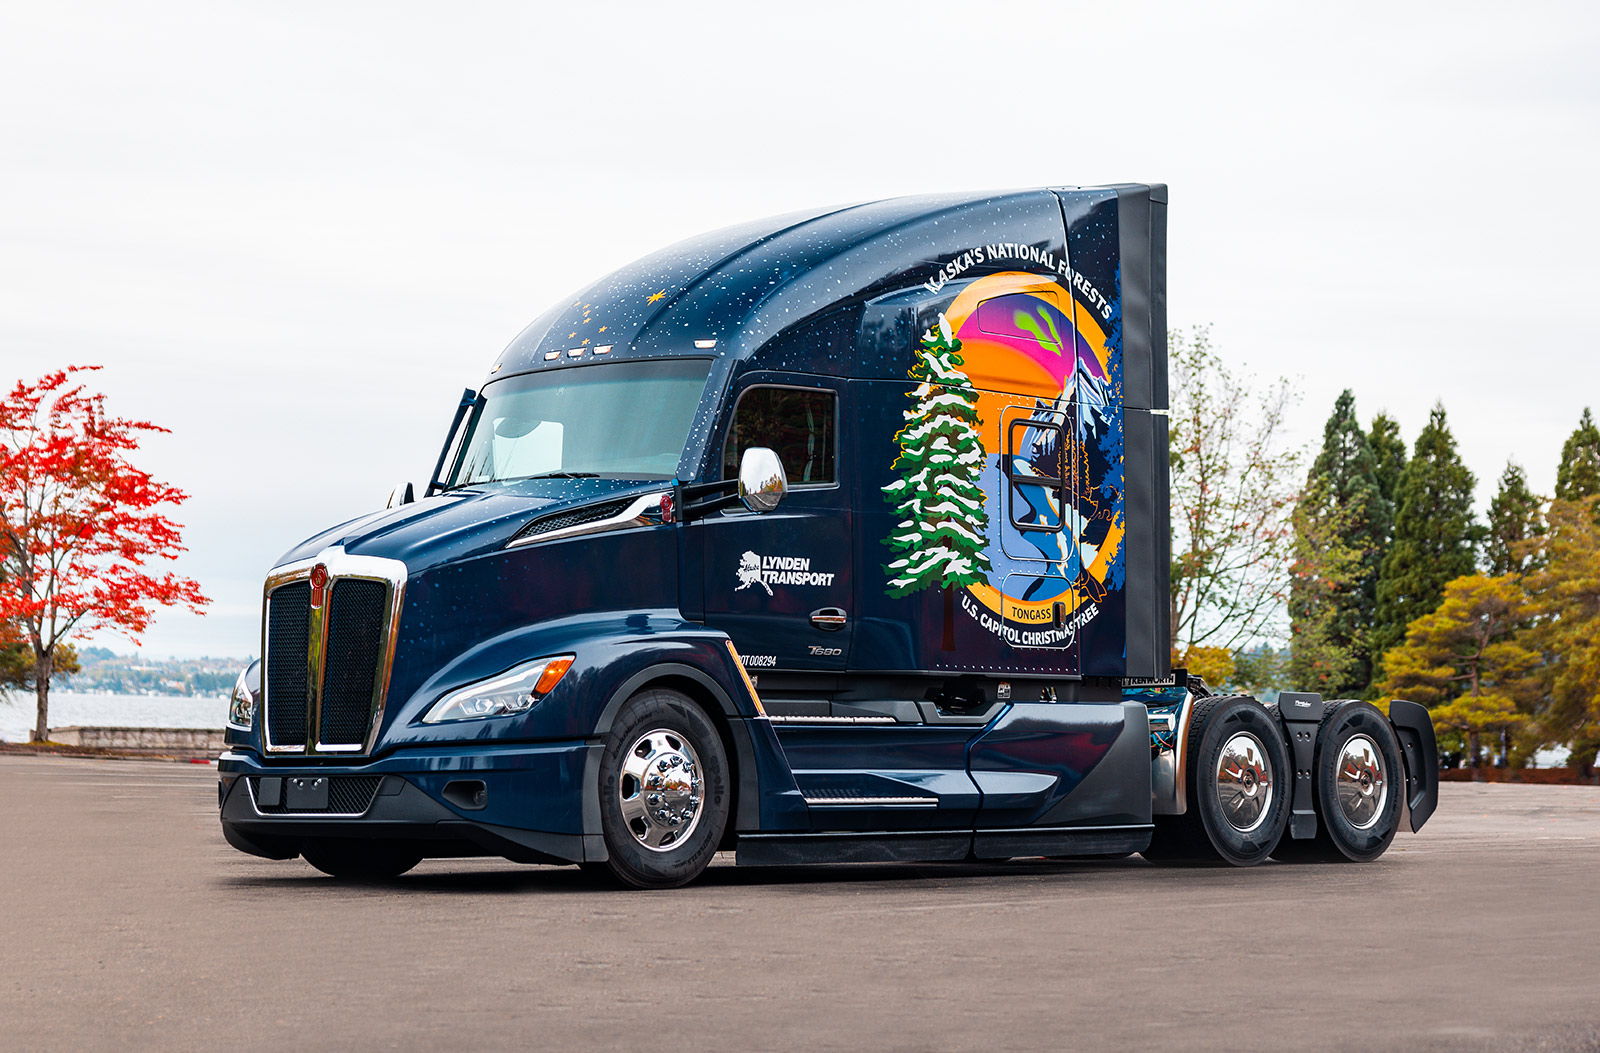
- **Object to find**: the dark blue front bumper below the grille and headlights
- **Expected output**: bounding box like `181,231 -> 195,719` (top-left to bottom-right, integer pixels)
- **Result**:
218,741 -> 605,863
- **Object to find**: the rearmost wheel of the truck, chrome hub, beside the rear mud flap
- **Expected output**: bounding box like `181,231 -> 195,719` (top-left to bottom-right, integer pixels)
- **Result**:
1274,699 -> 1405,863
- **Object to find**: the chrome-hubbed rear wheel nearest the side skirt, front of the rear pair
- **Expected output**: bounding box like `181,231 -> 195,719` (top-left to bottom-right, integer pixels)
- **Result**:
1144,695 -> 1294,866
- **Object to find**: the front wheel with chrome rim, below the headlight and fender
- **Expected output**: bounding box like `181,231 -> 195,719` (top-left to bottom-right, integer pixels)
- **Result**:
600,688 -> 731,888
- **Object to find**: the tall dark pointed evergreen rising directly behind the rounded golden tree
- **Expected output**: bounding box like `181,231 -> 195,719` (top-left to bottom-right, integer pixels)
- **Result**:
1373,403 -> 1482,679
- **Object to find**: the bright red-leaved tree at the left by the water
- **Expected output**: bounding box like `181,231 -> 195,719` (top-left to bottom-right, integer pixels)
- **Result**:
0,366 -> 210,743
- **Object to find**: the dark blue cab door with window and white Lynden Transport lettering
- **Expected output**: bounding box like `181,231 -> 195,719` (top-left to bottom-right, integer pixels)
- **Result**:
696,373 -> 853,674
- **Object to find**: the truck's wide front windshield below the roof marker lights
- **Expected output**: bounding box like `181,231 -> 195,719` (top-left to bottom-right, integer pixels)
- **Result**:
445,358 -> 710,486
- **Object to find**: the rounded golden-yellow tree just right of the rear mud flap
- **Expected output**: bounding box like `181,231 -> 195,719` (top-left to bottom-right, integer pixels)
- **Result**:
1381,575 -> 1541,768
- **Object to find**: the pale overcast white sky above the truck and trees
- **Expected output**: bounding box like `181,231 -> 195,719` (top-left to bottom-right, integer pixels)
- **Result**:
0,0 -> 1600,656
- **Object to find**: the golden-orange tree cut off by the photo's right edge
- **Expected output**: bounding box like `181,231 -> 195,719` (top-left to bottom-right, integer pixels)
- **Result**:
1525,496 -> 1600,770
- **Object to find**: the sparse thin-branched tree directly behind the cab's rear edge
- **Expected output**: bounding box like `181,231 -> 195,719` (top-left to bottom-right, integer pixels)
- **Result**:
1168,326 -> 1302,659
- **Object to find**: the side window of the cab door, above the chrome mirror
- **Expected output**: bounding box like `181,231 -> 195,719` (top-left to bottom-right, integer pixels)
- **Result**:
722,387 -> 838,486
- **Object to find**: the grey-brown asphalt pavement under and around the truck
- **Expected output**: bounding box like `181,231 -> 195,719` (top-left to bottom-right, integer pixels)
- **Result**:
0,755 -> 1600,1053
